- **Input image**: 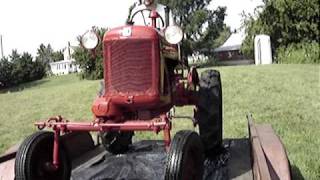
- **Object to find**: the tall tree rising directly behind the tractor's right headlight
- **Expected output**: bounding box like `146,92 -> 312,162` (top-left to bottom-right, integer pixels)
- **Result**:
160,0 -> 226,58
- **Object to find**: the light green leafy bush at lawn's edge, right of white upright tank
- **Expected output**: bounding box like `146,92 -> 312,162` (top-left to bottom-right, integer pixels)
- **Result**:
277,42 -> 320,64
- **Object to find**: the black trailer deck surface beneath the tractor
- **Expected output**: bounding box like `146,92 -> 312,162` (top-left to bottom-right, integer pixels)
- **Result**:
72,139 -> 253,180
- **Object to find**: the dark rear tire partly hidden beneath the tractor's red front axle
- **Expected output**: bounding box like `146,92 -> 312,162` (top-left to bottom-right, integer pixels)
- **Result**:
100,131 -> 134,154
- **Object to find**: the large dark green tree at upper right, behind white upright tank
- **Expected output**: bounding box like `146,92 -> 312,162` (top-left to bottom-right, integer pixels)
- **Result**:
242,0 -> 320,57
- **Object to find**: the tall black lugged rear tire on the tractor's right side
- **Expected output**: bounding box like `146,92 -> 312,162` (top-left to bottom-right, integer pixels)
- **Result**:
195,70 -> 223,158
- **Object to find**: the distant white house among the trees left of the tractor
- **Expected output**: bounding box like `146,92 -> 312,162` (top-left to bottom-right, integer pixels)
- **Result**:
50,45 -> 80,75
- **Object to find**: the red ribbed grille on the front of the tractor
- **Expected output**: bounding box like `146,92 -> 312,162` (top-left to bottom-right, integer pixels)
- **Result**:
105,39 -> 153,94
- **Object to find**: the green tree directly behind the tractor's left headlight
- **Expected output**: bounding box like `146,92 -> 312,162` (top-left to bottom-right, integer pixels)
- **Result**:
72,27 -> 107,79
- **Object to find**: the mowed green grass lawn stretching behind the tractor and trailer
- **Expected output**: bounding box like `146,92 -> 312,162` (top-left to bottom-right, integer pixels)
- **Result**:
0,65 -> 320,179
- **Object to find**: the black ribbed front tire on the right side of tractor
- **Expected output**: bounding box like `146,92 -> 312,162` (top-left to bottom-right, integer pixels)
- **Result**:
165,130 -> 204,180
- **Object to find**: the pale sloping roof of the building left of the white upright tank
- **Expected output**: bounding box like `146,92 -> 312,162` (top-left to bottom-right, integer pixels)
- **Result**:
214,31 -> 245,52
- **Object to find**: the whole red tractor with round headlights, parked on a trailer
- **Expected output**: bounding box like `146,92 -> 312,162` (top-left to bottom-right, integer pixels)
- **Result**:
15,9 -> 222,180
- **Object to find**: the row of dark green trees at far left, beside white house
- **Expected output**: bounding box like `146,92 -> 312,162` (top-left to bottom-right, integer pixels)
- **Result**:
0,44 -> 63,89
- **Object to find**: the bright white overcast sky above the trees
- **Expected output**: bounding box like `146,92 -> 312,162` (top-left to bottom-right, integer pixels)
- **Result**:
0,0 -> 261,56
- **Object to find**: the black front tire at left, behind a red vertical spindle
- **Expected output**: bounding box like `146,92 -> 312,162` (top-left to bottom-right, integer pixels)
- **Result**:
15,131 -> 71,180
